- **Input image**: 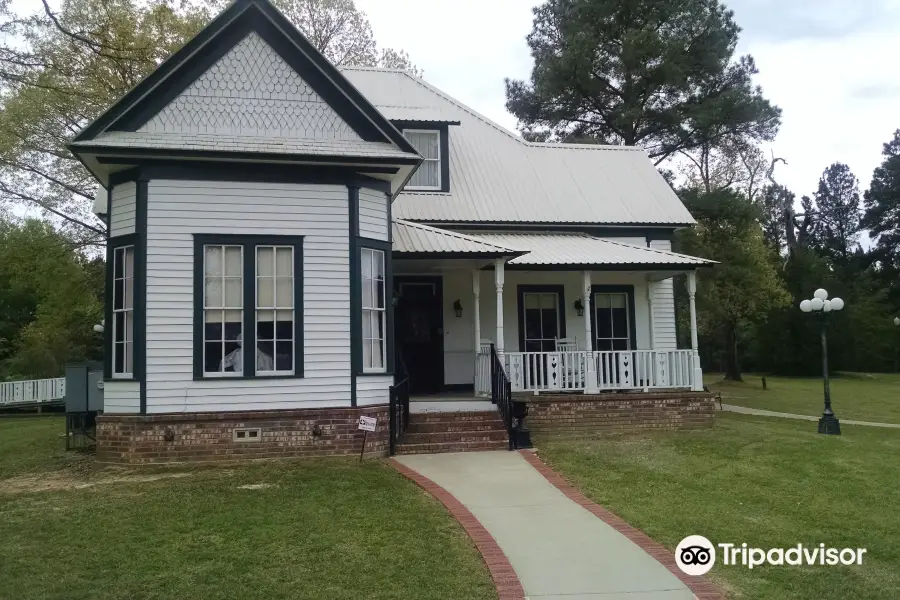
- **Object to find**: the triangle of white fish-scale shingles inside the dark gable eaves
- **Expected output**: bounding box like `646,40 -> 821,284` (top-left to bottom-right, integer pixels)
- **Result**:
138,31 -> 362,141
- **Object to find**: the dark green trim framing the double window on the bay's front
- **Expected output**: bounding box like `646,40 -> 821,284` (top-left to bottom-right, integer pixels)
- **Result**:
194,233 -> 304,382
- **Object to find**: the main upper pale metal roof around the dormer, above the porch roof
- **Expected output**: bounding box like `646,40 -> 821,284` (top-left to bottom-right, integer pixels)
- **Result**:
343,67 -> 694,227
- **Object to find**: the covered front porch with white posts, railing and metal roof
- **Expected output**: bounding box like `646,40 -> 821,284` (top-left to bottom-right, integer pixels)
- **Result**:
393,223 -> 709,397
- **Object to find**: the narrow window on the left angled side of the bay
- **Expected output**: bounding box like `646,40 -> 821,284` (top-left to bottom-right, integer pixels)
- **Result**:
112,246 -> 134,378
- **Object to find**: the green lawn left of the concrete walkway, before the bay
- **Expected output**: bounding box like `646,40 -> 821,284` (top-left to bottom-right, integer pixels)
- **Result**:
0,419 -> 496,600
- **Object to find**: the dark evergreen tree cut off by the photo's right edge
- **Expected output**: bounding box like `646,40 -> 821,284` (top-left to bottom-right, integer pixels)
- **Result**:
862,129 -> 900,298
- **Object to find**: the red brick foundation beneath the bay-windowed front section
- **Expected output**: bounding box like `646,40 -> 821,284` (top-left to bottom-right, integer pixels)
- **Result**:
97,405 -> 388,465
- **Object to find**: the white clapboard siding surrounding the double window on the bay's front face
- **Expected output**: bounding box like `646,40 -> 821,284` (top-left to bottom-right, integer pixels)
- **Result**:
147,180 -> 350,413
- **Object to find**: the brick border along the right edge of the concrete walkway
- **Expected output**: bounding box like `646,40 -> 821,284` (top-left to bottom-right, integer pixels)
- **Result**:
519,450 -> 725,600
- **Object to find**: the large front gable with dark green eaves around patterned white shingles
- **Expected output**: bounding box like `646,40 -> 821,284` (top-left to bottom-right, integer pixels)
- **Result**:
73,0 -> 418,157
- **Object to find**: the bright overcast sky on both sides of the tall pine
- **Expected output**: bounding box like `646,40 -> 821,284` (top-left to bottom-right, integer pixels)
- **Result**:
356,0 -> 900,196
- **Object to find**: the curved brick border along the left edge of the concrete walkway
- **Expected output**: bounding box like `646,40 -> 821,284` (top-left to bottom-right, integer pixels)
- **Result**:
390,459 -> 528,600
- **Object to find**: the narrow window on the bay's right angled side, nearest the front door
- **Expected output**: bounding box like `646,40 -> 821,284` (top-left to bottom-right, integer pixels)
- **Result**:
360,248 -> 387,373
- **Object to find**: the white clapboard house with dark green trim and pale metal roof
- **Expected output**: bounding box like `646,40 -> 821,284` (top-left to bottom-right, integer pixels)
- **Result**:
70,0 -> 709,462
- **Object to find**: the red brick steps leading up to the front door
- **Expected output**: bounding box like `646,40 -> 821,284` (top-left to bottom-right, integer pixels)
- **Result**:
397,411 -> 509,454
